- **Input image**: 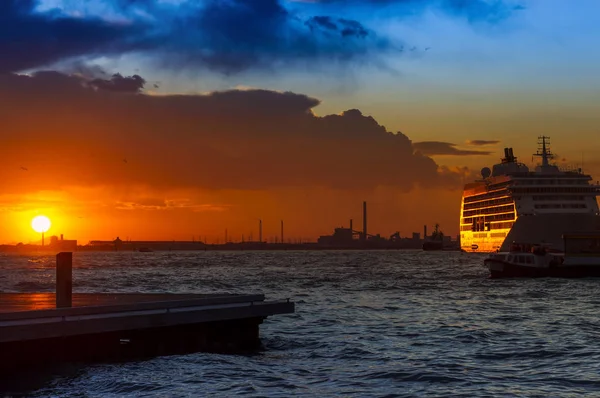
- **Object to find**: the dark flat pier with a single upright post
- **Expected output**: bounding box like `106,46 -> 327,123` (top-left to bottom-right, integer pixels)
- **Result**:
0,253 -> 294,369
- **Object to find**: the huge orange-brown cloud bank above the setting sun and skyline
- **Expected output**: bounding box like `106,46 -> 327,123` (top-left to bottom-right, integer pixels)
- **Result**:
0,72 -> 461,191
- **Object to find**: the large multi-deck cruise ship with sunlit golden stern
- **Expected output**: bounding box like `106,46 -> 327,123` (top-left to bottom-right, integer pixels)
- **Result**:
460,136 -> 600,253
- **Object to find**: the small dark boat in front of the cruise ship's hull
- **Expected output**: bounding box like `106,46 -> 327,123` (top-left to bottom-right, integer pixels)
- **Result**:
483,232 -> 600,278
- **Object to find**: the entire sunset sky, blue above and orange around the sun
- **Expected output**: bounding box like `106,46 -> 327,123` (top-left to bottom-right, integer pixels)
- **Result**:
0,0 -> 600,244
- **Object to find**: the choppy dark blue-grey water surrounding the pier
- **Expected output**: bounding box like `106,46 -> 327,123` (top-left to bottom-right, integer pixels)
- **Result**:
0,251 -> 600,397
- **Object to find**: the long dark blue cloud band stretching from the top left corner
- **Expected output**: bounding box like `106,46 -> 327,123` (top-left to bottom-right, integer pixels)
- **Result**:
0,0 -> 400,73
